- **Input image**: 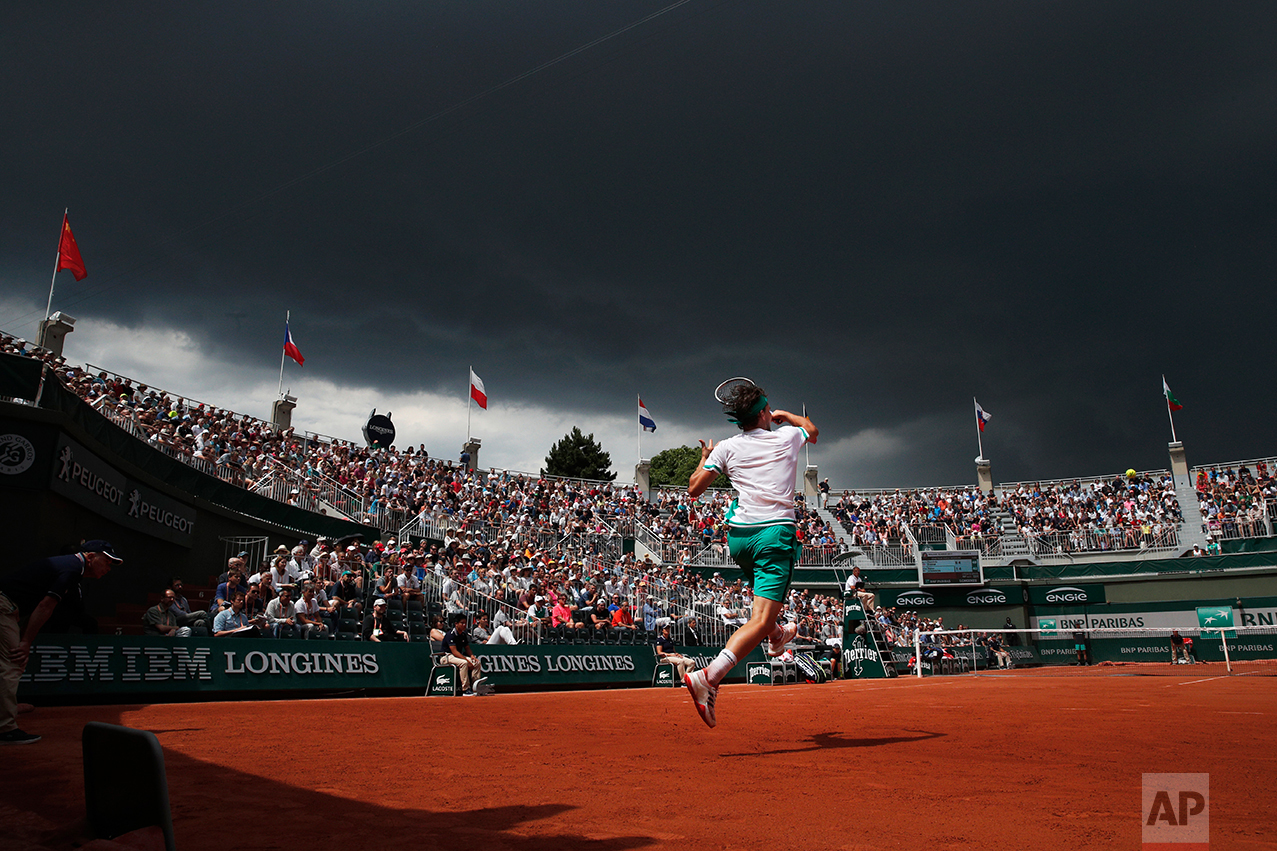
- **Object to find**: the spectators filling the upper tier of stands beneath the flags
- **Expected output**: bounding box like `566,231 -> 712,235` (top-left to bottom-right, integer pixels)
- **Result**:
0,335 -> 1277,577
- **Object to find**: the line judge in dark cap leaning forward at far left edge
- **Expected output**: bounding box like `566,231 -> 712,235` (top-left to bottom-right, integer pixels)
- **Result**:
0,541 -> 124,745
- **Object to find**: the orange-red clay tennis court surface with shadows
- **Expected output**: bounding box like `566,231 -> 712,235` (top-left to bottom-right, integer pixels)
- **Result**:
0,666 -> 1277,851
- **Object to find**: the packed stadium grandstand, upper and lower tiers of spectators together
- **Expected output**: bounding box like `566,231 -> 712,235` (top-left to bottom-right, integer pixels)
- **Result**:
0,324 -> 1277,690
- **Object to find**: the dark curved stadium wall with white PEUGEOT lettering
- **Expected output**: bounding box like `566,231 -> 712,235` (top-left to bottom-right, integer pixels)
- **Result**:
0,401 -> 379,615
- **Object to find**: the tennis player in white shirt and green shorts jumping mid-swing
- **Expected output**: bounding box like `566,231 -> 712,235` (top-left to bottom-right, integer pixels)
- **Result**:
683,378 -> 819,727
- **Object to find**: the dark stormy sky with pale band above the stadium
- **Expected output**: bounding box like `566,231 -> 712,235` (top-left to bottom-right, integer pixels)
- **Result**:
0,0 -> 1277,487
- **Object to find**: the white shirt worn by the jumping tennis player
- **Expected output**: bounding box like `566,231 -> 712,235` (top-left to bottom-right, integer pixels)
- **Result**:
705,426 -> 808,529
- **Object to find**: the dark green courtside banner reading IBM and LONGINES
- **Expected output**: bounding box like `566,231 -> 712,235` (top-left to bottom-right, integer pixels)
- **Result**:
20,635 -> 762,698
